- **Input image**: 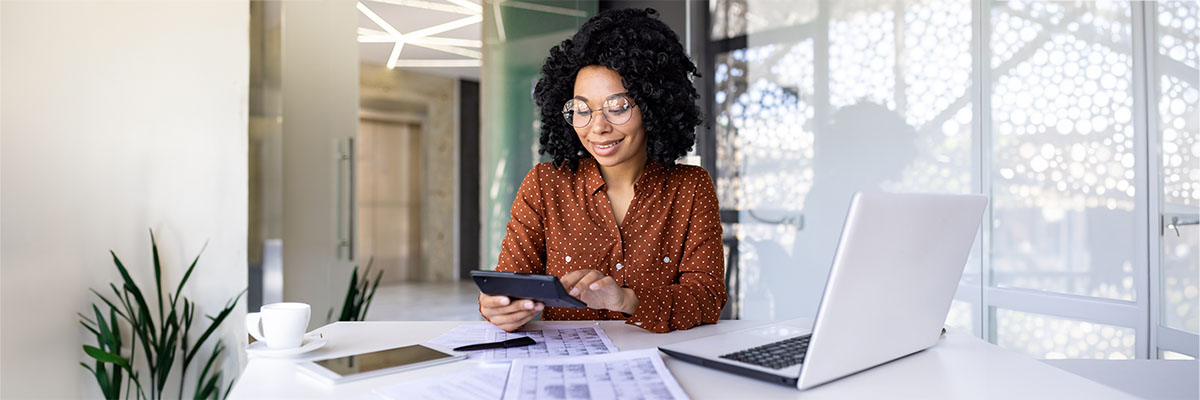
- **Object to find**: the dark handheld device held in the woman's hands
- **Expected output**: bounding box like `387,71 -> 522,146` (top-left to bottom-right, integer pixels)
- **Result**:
470,270 -> 588,309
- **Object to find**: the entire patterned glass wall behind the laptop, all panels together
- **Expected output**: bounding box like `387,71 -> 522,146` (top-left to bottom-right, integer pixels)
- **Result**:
708,0 -> 1200,358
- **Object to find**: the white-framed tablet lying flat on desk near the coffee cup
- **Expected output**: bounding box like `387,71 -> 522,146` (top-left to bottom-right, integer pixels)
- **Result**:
300,345 -> 467,384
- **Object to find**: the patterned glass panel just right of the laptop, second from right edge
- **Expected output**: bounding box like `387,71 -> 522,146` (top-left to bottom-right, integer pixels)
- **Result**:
989,1 -> 1148,358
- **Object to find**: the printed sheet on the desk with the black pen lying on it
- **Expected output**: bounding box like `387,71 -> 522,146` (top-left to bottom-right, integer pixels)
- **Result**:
430,324 -> 617,360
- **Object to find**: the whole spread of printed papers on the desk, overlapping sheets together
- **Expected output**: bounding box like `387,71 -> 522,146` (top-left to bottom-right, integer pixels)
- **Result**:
373,324 -> 688,400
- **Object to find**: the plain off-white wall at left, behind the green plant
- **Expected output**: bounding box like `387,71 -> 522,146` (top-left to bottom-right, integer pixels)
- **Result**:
0,1 -> 248,399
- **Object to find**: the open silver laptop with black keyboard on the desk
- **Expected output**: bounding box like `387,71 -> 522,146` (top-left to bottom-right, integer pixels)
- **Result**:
659,192 -> 988,389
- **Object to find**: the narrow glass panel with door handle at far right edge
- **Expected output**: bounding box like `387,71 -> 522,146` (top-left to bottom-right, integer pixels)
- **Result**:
1147,1 -> 1200,356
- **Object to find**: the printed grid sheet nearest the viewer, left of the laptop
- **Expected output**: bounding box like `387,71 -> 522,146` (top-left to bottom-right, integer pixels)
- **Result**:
504,348 -> 688,400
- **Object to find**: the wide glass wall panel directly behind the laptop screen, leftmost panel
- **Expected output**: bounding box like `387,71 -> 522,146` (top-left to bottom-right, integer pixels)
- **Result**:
710,0 -> 979,329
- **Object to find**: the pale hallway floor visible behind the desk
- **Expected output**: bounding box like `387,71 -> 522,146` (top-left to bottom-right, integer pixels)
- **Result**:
366,281 -> 484,321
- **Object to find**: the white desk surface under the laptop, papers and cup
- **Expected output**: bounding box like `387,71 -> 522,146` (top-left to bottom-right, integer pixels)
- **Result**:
230,321 -> 1132,399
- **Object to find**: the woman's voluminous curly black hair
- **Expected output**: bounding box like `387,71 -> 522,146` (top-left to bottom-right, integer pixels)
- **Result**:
534,8 -> 702,171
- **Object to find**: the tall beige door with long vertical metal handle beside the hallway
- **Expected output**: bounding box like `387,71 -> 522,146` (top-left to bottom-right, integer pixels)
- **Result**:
280,0 -> 359,328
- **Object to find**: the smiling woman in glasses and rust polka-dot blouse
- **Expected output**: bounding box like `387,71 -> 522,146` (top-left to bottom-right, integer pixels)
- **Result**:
479,8 -> 726,333
